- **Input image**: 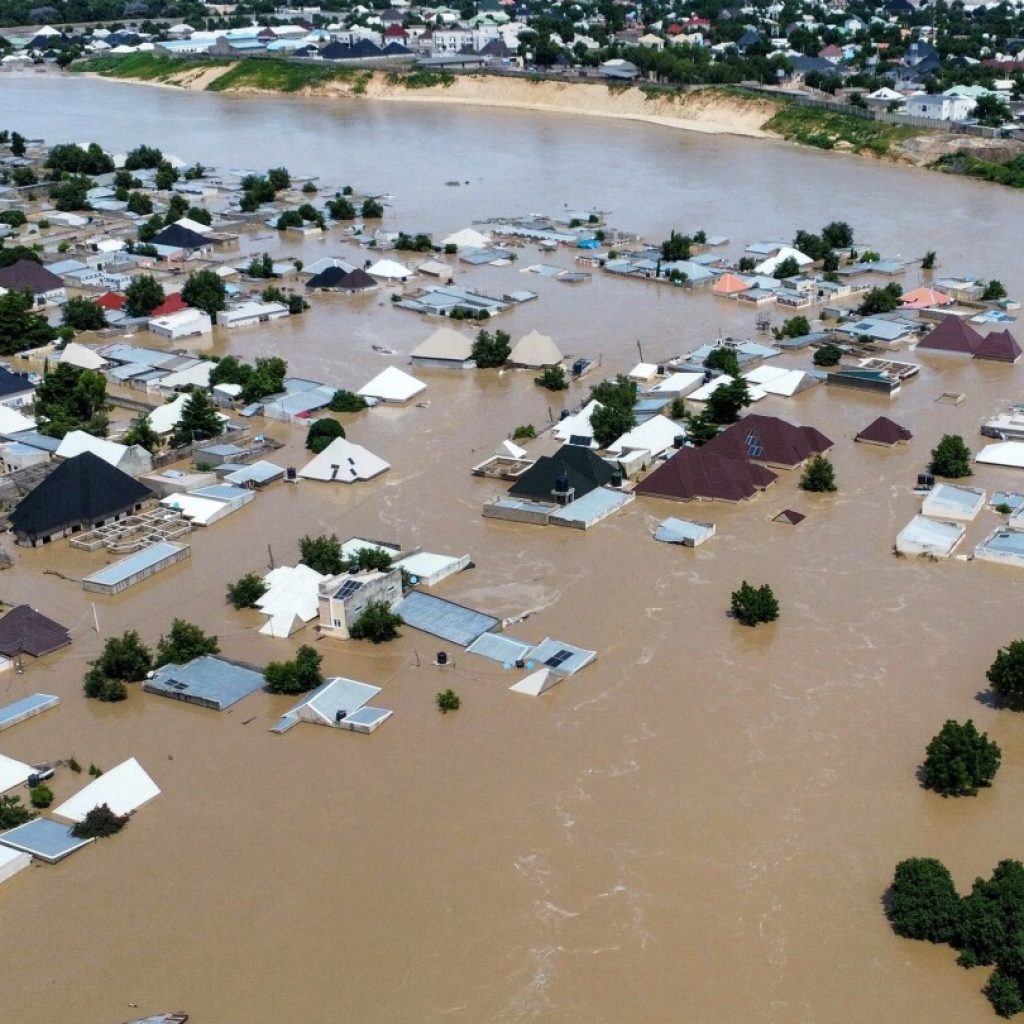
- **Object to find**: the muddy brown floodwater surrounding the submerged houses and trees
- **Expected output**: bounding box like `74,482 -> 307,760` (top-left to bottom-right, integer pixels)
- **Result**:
0,76 -> 1024,1024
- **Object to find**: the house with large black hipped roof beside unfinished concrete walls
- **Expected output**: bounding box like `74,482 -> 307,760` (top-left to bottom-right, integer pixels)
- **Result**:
10,452 -> 153,547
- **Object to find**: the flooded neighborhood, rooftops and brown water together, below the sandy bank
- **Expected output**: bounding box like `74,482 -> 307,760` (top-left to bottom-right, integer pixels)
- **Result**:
0,64 -> 1024,1024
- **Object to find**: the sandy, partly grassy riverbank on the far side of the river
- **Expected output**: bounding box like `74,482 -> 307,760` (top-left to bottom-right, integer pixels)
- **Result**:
74,53 -> 1024,176
